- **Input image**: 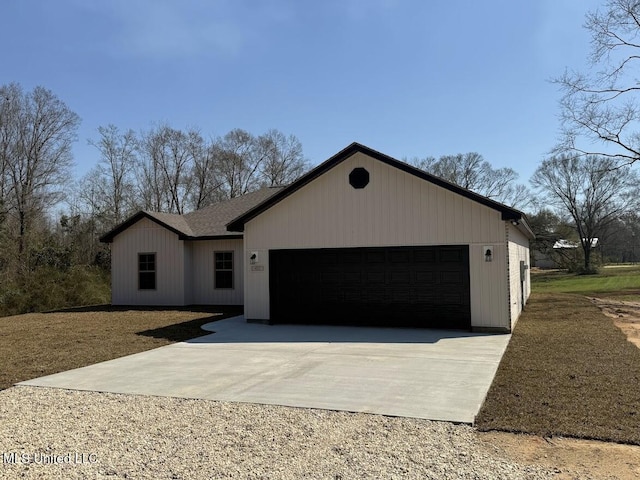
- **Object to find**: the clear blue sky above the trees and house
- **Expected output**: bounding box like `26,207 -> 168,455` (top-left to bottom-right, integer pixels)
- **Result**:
0,0 -> 602,185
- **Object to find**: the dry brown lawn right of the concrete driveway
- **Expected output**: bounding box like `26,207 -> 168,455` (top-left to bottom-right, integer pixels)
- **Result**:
476,292 -> 640,445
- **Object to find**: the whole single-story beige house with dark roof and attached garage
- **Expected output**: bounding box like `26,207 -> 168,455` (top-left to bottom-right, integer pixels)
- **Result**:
101,143 -> 533,332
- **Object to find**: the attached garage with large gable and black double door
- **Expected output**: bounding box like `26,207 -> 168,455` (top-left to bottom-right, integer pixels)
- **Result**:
227,143 -> 533,332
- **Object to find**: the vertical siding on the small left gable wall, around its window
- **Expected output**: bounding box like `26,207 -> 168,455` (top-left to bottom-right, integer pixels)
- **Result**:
111,218 -> 185,305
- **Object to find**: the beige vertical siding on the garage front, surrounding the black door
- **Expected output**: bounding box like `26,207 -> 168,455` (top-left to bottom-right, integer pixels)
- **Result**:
244,153 -> 510,329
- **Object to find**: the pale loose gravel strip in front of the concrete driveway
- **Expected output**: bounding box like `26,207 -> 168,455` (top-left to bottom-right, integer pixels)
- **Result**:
0,386 -> 588,480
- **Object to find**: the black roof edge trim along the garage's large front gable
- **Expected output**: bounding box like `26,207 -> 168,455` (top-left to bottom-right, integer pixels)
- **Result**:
227,142 -> 535,238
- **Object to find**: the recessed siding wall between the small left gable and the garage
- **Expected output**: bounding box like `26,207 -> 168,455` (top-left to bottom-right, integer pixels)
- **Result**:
185,239 -> 244,305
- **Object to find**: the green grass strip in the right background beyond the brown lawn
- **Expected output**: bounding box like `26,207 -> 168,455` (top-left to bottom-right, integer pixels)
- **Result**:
531,266 -> 640,297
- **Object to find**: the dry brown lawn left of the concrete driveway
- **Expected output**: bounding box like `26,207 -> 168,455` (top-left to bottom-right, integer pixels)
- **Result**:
0,306 -> 242,390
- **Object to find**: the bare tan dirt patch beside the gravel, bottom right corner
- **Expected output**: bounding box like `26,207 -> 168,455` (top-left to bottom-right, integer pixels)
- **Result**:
478,432 -> 640,480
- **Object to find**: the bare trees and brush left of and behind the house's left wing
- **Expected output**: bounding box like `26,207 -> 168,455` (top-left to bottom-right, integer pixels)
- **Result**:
0,83 -> 308,315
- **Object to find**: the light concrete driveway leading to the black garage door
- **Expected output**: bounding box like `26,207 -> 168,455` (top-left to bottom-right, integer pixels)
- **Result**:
19,317 -> 510,423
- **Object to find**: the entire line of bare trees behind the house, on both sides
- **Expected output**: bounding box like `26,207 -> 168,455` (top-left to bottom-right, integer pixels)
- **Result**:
0,83 -> 640,315
